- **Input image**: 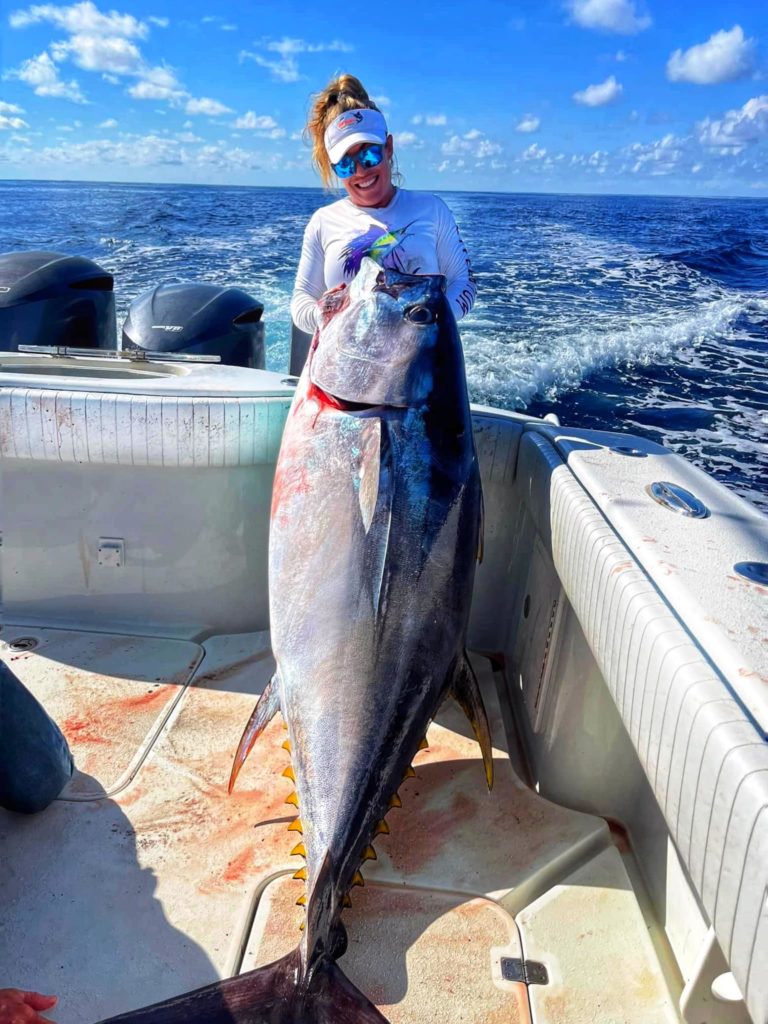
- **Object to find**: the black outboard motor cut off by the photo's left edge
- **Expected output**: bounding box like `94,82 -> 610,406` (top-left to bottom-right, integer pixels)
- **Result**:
0,252 -> 116,352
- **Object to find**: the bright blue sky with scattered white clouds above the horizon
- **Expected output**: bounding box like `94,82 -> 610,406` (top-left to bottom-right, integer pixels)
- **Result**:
0,0 -> 768,197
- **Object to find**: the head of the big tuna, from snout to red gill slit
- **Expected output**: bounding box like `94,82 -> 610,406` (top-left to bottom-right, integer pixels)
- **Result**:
309,259 -> 456,408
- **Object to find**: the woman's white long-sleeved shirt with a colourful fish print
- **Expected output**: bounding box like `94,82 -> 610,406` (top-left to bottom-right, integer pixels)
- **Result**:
291,188 -> 476,334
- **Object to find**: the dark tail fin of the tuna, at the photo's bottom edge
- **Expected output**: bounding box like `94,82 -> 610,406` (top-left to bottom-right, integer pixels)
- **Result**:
94,949 -> 388,1024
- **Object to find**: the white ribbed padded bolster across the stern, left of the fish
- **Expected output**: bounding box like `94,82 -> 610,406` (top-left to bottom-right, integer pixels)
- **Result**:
0,388 -> 290,468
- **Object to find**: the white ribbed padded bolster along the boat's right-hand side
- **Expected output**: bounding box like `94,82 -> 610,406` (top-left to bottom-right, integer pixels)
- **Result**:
518,433 -> 768,1021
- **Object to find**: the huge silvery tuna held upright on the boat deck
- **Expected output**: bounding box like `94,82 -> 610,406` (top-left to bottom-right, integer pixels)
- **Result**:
99,260 -> 493,1024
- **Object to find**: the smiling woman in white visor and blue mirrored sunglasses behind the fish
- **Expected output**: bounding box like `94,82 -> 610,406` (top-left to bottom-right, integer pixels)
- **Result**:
291,75 -> 475,334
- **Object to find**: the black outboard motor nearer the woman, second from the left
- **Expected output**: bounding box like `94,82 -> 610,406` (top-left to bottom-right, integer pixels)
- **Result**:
123,284 -> 265,370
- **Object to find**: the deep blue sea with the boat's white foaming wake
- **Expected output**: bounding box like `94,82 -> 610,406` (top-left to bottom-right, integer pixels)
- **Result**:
0,181 -> 768,511
